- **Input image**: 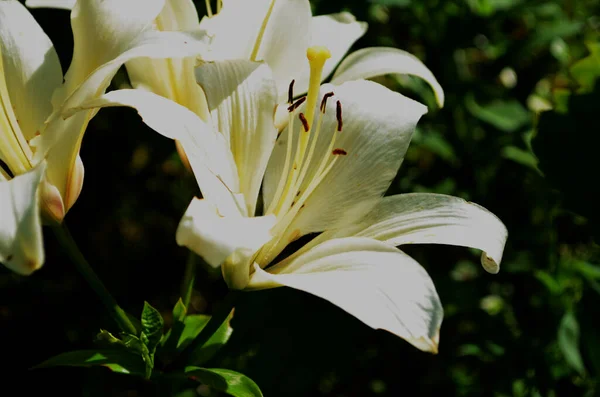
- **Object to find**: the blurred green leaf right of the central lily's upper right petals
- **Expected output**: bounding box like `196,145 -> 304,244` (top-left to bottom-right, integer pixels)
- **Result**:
465,94 -> 532,132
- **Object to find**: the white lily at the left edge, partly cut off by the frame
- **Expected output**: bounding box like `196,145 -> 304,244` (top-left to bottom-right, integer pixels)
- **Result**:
0,0 -> 209,274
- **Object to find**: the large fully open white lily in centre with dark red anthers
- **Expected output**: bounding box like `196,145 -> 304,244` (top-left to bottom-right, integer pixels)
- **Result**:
81,47 -> 506,352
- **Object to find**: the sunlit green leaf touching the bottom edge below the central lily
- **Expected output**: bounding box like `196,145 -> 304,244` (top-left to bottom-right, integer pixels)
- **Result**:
185,367 -> 262,397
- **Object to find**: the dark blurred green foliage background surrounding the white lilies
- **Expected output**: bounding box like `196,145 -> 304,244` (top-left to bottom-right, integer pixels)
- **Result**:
0,0 -> 600,397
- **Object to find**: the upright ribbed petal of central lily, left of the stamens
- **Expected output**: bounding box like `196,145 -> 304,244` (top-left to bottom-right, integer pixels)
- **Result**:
196,60 -> 277,216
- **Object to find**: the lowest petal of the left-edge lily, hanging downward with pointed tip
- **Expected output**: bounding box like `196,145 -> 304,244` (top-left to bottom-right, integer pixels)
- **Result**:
0,162 -> 46,275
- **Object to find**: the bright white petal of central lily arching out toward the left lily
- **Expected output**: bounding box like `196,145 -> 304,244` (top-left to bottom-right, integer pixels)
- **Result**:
76,90 -> 243,215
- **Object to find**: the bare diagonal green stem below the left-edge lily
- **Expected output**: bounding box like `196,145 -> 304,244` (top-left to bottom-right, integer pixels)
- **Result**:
52,222 -> 137,335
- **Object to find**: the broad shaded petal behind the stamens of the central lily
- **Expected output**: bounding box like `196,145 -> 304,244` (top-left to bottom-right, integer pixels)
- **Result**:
263,80 -> 427,249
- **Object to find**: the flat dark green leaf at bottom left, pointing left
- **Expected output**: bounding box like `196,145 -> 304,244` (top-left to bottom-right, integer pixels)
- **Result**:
33,350 -> 145,376
